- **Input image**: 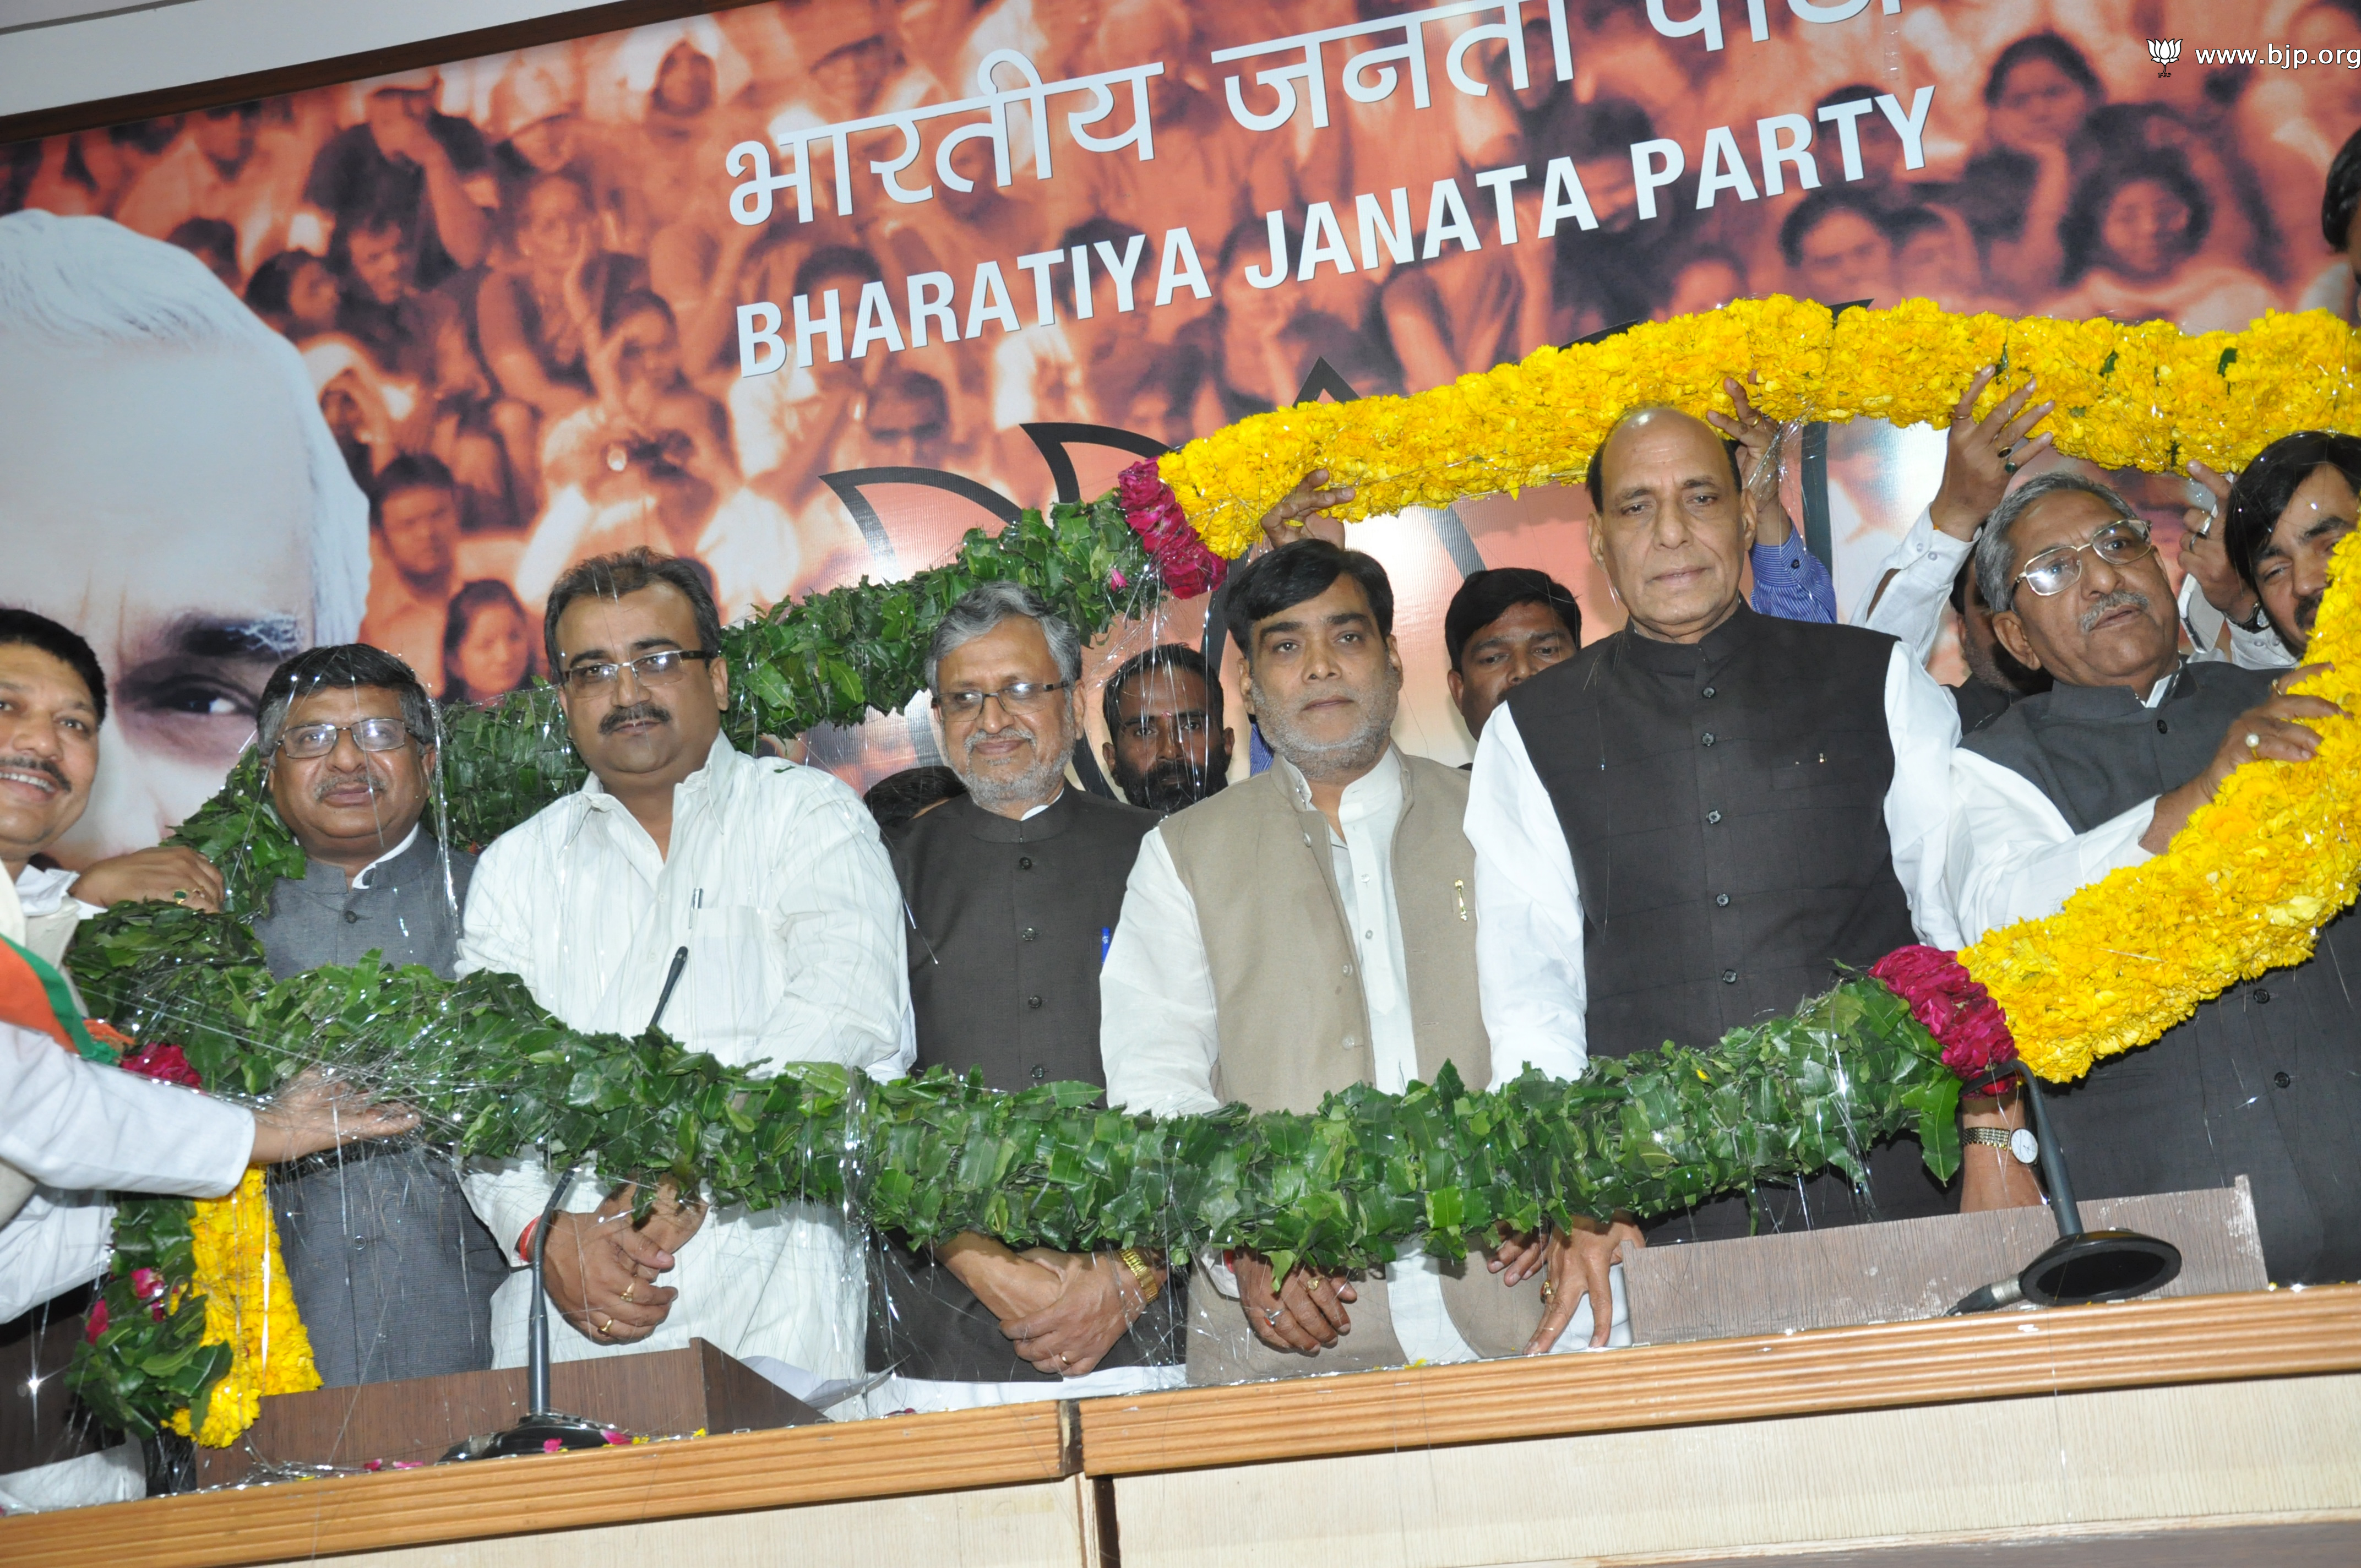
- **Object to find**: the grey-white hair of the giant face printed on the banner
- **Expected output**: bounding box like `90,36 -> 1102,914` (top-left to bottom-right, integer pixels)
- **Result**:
0,213 -> 368,643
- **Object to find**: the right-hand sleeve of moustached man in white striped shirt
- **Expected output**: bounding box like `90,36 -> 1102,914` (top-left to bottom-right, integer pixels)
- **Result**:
755,770 -> 913,1068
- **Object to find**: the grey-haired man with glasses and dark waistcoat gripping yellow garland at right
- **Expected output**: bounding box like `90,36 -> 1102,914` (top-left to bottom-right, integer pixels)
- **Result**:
1948,472 -> 2361,1282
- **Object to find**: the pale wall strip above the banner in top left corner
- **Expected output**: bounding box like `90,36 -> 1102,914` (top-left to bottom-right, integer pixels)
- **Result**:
0,0 -> 618,116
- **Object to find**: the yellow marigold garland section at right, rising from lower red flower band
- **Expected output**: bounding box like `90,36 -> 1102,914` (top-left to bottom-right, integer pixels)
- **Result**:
1960,533 -> 2361,1081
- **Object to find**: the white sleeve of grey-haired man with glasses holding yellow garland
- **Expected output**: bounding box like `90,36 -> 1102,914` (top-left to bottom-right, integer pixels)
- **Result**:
1948,751 -> 2156,942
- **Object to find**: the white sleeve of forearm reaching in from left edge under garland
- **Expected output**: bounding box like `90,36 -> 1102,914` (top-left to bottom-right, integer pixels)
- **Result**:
0,1022 -> 255,1197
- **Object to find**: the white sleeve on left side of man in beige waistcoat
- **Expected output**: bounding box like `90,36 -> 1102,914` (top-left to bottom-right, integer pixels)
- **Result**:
1098,829 -> 1221,1117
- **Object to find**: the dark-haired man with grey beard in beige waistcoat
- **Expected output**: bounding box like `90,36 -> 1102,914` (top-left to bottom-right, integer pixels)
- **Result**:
1100,538 -> 1589,1384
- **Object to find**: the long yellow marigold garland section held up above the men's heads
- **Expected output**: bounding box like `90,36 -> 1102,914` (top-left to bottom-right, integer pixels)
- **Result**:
1157,295 -> 2361,560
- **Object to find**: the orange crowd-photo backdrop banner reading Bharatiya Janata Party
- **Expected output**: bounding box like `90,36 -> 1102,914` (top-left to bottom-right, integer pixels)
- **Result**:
0,0 -> 2361,864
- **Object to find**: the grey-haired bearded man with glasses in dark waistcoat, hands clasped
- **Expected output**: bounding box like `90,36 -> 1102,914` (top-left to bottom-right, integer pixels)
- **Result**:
869,583 -> 1180,1410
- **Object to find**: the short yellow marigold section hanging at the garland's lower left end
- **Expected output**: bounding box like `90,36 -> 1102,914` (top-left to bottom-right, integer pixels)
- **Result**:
172,1171 -> 319,1447
